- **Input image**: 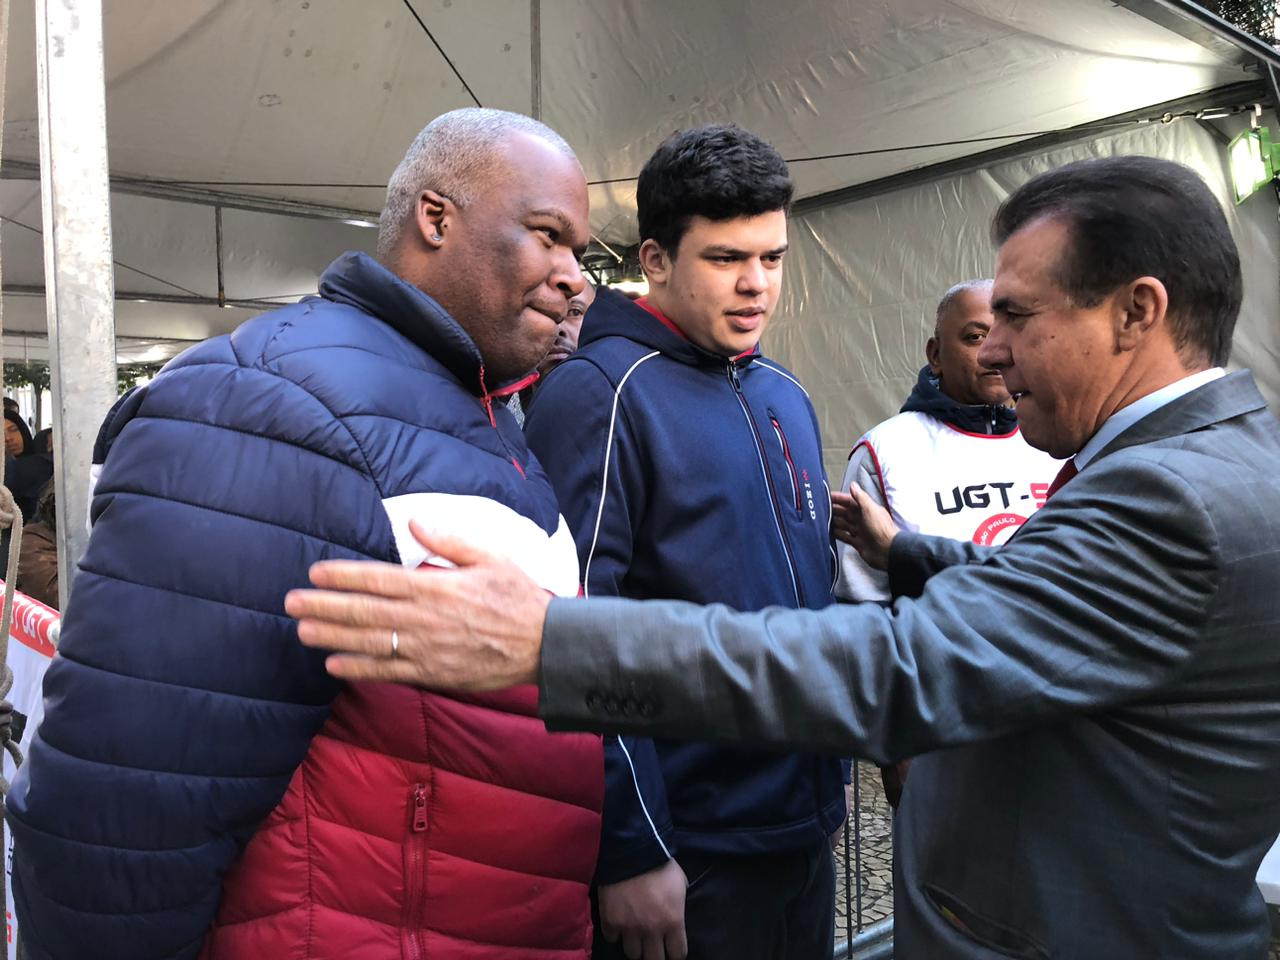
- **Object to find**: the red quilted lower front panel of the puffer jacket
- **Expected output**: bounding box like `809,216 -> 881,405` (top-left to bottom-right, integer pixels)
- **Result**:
201,684 -> 603,960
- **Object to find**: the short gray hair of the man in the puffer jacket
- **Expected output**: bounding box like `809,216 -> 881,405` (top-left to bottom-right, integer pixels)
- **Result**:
378,106 -> 576,264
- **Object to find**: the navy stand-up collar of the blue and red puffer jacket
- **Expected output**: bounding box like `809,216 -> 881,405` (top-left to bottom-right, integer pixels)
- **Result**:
320,251 -> 506,396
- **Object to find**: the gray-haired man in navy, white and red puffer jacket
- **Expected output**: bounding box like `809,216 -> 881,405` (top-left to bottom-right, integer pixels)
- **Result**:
9,110 -> 603,960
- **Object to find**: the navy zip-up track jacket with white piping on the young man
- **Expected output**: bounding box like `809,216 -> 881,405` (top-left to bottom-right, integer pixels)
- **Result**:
525,289 -> 845,883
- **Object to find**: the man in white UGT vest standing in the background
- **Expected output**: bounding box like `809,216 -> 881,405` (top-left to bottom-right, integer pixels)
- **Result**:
835,280 -> 1060,809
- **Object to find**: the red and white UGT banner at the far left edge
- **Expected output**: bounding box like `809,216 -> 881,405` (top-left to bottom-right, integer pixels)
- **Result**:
0,591 -> 59,960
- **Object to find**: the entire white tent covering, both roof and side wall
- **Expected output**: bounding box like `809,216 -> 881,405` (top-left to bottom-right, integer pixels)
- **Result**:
0,0 -> 1280,435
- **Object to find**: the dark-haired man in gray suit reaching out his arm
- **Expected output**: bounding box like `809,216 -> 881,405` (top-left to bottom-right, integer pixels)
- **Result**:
288,157 -> 1280,960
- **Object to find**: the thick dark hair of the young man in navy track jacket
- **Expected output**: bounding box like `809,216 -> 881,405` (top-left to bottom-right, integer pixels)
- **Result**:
636,124 -> 795,257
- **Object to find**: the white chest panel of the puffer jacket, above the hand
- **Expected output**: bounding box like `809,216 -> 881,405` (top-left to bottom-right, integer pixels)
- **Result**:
383,493 -> 577,596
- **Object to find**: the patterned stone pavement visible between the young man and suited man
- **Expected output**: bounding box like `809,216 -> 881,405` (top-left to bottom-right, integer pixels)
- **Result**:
836,763 -> 1280,960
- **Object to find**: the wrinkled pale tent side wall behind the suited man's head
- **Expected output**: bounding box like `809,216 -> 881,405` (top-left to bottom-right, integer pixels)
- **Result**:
764,122 -> 1280,483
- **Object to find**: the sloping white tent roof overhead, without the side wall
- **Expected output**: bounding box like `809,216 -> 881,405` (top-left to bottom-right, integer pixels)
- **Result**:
4,0 -> 1245,229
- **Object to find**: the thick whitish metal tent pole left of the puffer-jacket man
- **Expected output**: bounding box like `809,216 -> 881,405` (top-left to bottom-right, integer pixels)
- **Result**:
36,0 -> 115,609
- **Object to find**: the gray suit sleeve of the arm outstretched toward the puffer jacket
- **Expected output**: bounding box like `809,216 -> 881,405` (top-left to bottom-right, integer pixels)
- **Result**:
540,452 -> 1220,763
